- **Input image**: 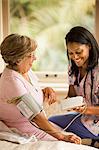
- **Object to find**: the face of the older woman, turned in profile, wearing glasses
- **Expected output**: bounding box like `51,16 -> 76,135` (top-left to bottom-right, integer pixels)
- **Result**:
17,51 -> 36,73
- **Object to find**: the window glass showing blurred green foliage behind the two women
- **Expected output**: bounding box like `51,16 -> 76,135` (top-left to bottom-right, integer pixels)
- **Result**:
10,0 -> 95,72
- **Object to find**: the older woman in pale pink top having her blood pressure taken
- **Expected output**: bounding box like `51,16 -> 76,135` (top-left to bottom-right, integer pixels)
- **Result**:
0,34 -> 80,144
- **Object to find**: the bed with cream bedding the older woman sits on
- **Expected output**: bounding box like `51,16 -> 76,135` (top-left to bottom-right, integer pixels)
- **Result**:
0,121 -> 98,150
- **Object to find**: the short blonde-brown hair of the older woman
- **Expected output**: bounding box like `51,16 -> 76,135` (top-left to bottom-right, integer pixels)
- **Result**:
0,34 -> 37,67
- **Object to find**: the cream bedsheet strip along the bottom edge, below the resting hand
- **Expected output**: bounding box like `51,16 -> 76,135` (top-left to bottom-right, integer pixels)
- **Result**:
0,141 -> 98,150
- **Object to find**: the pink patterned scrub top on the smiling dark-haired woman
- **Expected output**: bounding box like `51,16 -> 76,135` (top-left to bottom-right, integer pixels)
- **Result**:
69,66 -> 99,136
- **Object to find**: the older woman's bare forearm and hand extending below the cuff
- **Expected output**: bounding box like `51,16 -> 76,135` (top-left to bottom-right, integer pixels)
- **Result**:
32,112 -> 81,144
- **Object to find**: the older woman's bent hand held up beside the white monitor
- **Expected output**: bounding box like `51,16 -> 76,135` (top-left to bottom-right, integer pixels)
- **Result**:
42,87 -> 57,105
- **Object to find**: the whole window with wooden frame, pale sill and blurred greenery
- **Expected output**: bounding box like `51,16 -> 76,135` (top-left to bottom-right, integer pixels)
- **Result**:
0,0 -> 96,96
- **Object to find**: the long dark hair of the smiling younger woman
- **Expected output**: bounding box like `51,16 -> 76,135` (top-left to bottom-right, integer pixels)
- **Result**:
65,26 -> 99,103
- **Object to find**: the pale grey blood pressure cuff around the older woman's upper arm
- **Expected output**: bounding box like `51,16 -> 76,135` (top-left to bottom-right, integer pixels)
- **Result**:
16,93 -> 43,120
